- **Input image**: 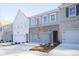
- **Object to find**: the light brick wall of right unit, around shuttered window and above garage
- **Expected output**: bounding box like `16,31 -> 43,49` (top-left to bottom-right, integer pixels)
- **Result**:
60,4 -> 79,41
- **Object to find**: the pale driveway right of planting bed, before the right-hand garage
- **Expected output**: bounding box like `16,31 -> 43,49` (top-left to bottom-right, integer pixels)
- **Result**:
48,43 -> 79,56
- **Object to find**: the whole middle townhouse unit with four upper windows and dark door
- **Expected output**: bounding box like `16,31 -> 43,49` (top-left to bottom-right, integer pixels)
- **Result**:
29,9 -> 61,44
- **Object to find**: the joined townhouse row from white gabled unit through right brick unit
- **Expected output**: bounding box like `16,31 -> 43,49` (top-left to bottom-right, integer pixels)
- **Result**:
13,3 -> 79,44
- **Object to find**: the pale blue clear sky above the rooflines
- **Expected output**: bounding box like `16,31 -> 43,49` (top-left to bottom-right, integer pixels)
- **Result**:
0,3 -> 61,22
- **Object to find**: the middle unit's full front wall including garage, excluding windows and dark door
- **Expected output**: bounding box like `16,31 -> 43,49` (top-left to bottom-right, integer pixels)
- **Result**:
29,9 -> 61,43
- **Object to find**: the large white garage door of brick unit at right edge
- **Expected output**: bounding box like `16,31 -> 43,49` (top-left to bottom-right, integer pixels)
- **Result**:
62,30 -> 79,43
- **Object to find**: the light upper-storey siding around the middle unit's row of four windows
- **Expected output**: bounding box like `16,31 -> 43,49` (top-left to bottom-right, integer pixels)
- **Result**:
29,9 -> 59,28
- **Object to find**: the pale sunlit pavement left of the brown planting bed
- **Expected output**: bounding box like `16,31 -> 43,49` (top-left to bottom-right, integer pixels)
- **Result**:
0,43 -> 47,56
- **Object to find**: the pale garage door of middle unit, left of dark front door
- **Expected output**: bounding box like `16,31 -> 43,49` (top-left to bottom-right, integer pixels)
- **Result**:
31,32 -> 50,44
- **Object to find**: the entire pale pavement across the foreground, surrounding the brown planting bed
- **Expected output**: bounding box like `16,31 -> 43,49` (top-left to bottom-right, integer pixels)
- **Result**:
0,43 -> 79,56
